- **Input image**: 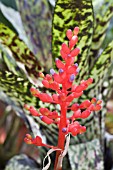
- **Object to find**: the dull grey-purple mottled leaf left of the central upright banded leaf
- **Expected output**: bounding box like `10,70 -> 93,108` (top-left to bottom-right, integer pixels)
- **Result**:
16,0 -> 52,71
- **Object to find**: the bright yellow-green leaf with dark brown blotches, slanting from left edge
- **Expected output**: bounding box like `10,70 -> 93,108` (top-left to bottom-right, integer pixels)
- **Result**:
0,24 -> 42,77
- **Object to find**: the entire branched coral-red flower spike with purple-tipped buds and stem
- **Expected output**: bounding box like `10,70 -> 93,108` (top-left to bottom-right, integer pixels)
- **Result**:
24,27 -> 102,170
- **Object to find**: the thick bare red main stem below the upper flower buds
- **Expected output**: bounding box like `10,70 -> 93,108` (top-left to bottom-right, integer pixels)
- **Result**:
54,102 -> 67,170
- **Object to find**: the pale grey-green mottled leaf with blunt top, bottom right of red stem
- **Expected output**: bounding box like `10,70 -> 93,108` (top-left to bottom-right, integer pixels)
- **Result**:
68,139 -> 103,170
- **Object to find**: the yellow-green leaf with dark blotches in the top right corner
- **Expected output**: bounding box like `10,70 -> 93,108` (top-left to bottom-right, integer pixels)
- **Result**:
90,0 -> 113,68
